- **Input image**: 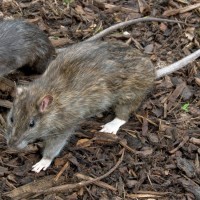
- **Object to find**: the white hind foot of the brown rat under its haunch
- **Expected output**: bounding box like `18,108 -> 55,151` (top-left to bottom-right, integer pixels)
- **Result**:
100,118 -> 126,134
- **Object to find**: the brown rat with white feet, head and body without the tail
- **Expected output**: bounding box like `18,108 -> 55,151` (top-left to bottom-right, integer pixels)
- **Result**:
7,42 -> 155,172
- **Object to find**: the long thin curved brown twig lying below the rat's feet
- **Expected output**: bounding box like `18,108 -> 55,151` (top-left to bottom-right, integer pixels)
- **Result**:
37,149 -> 125,194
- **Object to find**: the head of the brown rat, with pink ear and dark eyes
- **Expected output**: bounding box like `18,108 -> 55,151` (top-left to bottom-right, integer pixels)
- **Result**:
6,87 -> 53,149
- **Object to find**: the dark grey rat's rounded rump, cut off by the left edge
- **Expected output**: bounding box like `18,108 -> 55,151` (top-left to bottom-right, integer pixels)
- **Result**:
0,20 -> 55,76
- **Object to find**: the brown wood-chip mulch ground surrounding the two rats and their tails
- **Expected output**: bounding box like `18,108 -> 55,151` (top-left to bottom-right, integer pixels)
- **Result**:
0,0 -> 200,200
